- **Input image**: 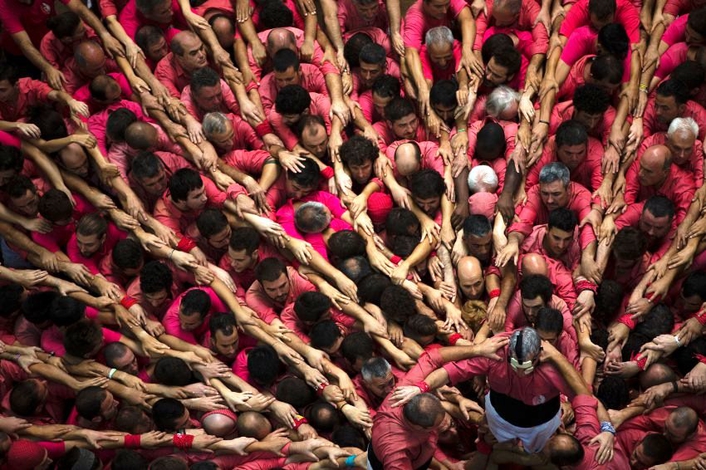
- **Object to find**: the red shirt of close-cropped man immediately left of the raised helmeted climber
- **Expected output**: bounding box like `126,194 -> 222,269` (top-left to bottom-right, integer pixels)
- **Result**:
370,349 -> 442,470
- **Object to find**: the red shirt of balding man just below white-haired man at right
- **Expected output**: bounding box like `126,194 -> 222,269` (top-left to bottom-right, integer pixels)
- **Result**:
625,158 -> 695,224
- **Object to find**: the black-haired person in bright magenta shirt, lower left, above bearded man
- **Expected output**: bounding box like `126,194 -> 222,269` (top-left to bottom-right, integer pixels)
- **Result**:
162,287 -> 227,344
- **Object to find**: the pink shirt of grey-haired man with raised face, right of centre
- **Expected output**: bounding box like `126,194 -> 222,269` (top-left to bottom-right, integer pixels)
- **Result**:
508,181 -> 596,250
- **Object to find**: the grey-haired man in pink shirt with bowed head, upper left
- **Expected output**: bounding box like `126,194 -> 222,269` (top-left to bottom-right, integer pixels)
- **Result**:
201,111 -> 265,153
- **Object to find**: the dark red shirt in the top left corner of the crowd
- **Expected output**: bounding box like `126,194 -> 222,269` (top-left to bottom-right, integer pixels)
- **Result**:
0,0 -> 70,55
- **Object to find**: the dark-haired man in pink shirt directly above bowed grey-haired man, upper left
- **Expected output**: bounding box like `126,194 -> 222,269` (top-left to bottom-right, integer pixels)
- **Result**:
181,67 -> 240,122
